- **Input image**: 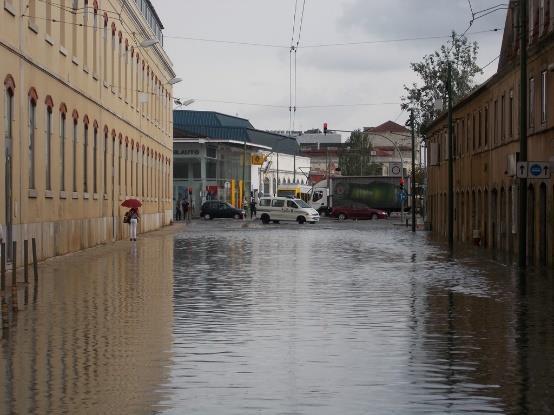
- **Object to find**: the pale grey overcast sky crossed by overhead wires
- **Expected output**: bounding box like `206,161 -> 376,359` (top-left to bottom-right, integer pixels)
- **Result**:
152,0 -> 506,130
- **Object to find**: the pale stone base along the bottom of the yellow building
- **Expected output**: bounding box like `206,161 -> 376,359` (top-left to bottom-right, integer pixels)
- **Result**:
3,210 -> 172,264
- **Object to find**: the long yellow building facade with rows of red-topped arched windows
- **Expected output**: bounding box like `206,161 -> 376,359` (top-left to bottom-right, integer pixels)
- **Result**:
0,0 -> 175,259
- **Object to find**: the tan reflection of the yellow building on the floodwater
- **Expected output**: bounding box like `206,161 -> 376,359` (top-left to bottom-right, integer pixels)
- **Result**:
0,237 -> 173,414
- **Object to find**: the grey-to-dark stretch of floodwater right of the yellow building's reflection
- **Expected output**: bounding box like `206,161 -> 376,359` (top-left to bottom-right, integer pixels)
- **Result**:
165,223 -> 554,414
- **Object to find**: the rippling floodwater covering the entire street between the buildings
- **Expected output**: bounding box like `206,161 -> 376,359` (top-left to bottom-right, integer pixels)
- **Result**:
0,220 -> 554,415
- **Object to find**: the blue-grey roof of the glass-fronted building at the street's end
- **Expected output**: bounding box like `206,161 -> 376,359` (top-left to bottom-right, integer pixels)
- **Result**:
173,110 -> 298,154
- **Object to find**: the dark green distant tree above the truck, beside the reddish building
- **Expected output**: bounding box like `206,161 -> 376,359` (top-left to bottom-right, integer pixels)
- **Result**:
339,130 -> 382,176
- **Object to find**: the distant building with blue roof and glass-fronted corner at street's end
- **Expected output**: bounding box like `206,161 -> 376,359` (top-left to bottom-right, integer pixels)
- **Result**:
173,110 -> 310,212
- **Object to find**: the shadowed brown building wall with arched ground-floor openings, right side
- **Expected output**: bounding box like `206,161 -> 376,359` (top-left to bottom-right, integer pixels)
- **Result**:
427,14 -> 554,263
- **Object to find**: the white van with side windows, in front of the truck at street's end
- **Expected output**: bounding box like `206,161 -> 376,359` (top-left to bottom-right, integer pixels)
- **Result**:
257,197 -> 319,225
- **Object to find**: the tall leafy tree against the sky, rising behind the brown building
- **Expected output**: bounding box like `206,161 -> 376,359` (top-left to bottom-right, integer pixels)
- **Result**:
400,32 -> 483,135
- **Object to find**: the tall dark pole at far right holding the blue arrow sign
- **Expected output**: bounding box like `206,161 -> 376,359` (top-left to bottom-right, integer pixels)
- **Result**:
518,0 -> 527,268
